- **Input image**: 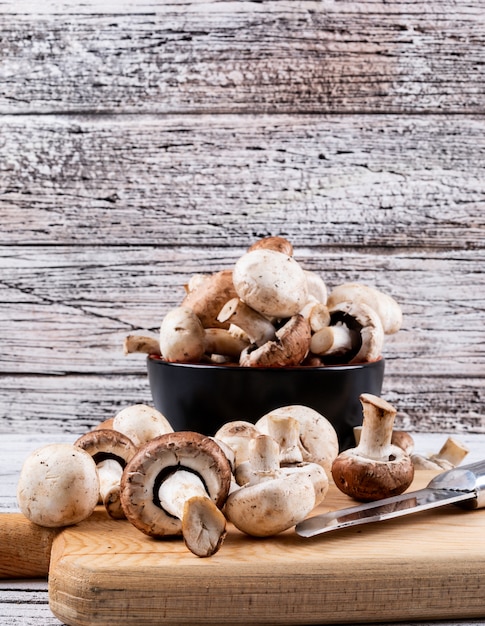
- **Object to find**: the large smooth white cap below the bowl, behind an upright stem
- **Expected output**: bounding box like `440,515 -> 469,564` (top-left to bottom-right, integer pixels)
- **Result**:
255,404 -> 339,477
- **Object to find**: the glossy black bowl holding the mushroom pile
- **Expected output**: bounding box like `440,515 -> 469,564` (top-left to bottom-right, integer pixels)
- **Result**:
147,356 -> 384,450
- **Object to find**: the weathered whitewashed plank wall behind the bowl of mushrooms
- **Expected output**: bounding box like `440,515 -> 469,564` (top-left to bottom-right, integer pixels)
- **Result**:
0,0 -> 485,438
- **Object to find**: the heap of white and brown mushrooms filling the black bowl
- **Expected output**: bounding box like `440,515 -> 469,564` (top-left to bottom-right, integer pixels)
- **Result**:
125,237 -> 402,367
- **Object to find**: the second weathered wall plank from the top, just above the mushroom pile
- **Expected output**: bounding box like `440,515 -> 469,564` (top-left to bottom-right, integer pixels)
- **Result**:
0,115 -> 485,245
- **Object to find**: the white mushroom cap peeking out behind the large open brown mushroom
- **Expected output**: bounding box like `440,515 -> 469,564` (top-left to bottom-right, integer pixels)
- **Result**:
113,404 -> 173,446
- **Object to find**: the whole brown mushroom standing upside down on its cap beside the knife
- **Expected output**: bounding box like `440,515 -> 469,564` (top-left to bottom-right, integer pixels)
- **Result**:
332,393 -> 414,502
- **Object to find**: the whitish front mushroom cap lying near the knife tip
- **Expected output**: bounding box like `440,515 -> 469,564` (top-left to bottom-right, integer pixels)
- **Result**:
224,472 -> 315,537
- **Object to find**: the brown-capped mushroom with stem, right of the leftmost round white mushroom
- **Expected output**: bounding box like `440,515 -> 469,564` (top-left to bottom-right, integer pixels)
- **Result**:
74,429 -> 137,519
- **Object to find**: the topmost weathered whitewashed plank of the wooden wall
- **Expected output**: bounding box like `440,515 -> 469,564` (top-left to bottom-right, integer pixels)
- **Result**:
0,0 -> 485,113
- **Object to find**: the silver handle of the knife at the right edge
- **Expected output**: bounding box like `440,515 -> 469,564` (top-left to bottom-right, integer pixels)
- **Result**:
428,460 -> 485,509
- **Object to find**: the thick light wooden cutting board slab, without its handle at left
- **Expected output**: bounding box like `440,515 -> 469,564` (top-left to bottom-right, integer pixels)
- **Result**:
43,472 -> 485,626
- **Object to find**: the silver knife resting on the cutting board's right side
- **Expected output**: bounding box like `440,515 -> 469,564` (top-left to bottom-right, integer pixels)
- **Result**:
295,460 -> 485,537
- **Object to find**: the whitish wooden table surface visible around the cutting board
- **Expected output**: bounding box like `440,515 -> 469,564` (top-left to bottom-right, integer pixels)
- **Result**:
0,433 -> 485,626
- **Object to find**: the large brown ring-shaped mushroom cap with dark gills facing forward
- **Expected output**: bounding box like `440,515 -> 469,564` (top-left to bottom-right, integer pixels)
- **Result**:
121,431 -> 232,537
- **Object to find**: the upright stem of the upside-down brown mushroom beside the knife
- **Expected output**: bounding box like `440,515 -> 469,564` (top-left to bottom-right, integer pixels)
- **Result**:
356,393 -> 396,461
